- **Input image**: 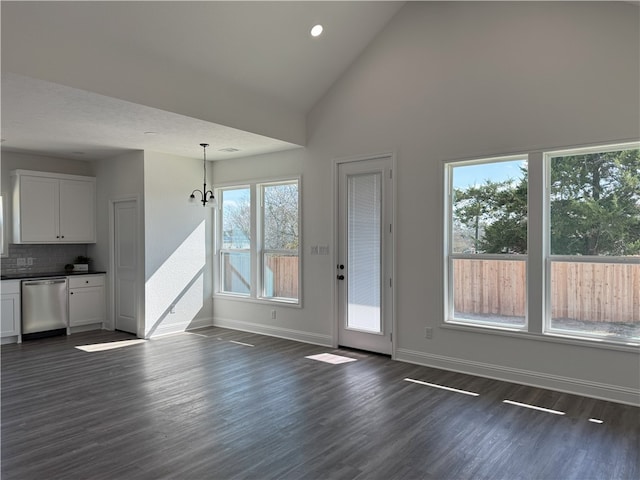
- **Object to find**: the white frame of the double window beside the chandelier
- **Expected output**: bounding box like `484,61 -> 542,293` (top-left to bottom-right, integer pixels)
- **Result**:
213,175 -> 303,307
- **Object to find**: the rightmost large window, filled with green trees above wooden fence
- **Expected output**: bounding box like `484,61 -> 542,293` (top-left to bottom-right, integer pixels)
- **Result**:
545,147 -> 640,341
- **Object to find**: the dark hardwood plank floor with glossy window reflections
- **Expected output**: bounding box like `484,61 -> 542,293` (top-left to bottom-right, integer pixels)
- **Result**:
1,327 -> 640,480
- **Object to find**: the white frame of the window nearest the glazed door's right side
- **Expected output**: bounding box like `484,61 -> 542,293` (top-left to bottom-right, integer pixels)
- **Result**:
444,154 -> 530,332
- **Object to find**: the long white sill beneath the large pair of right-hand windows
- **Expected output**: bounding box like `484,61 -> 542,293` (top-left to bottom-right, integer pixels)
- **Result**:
440,322 -> 640,353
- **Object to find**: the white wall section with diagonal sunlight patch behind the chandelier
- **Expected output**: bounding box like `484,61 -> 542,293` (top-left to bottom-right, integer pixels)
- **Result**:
144,152 -> 212,336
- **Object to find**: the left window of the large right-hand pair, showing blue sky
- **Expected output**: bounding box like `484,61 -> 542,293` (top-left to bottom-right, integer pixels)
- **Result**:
447,157 -> 527,329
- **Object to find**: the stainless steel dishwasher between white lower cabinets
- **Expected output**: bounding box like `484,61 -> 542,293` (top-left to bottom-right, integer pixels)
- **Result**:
22,277 -> 69,334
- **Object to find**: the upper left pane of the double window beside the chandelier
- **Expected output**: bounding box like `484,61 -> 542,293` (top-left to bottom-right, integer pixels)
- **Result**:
221,188 -> 251,249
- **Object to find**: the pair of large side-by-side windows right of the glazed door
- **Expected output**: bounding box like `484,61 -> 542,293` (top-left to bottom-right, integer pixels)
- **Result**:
445,144 -> 640,345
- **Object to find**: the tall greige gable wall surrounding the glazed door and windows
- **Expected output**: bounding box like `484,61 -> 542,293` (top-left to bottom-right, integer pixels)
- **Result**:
214,2 -> 640,403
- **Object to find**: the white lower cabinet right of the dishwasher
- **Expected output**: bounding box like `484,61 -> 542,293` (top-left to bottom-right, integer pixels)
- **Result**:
69,275 -> 106,327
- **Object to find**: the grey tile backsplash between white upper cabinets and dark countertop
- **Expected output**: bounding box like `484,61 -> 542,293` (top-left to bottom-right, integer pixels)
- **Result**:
0,244 -> 87,275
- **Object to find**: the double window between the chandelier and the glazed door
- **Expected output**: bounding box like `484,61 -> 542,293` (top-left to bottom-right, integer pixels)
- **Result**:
216,179 -> 300,304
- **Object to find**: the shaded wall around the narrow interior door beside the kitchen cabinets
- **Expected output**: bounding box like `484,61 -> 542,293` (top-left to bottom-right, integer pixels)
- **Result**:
88,151 -> 144,329
